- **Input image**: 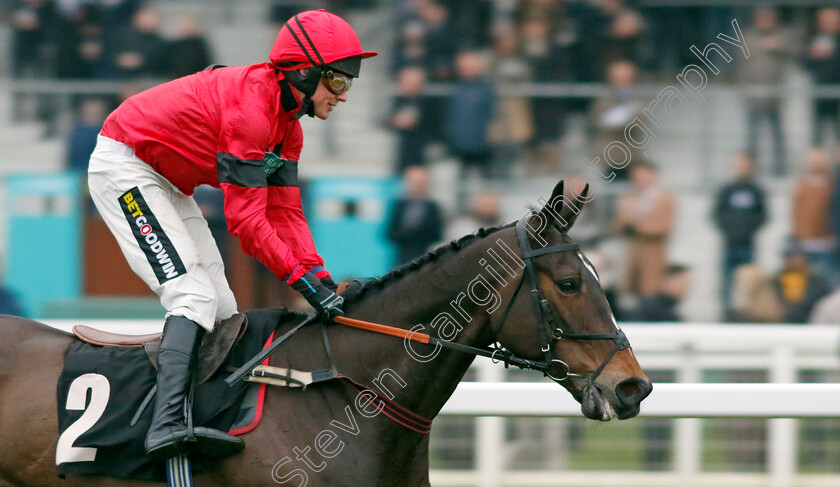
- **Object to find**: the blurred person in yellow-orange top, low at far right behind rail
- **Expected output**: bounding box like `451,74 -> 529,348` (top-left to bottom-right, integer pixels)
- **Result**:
775,247 -> 831,323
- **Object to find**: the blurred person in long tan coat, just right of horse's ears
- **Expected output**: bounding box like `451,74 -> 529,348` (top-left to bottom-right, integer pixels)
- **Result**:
613,161 -> 676,296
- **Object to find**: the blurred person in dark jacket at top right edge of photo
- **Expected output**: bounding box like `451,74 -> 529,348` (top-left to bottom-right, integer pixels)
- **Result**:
805,7 -> 840,145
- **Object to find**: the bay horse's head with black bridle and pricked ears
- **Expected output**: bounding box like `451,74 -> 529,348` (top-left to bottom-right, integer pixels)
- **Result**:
497,181 -> 652,421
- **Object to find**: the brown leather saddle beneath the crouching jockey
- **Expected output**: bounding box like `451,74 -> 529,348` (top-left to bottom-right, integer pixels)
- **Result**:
73,313 -> 248,384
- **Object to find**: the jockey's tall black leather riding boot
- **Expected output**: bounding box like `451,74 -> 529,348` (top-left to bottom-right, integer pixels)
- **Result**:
145,316 -> 245,460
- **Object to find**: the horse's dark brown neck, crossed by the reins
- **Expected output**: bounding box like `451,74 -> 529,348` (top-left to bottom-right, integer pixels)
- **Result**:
336,232 -> 512,418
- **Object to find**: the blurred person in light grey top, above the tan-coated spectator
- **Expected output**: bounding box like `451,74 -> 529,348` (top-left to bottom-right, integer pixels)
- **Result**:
591,61 -> 644,179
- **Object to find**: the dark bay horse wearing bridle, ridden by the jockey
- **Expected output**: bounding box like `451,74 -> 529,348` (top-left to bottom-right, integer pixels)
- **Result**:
0,181 -> 652,487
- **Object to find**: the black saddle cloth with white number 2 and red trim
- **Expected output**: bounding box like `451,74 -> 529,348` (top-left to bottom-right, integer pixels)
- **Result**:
56,309 -> 312,481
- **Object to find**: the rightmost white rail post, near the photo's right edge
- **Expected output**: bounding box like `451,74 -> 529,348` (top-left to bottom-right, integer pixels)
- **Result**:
767,346 -> 799,487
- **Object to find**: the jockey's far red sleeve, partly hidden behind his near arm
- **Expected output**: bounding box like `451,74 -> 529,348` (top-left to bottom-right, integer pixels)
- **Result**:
266,120 -> 329,278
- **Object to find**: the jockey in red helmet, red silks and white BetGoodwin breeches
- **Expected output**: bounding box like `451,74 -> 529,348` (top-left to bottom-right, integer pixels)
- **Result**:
88,10 -> 377,459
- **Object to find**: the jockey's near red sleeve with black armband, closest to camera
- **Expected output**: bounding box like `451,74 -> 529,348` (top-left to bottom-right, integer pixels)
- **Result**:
216,96 -> 300,279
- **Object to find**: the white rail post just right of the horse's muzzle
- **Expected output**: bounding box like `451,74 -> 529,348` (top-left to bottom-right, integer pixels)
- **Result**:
674,344 -> 703,486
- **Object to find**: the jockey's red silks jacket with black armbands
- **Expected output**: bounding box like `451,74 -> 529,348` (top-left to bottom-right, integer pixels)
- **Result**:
102,63 -> 328,280
